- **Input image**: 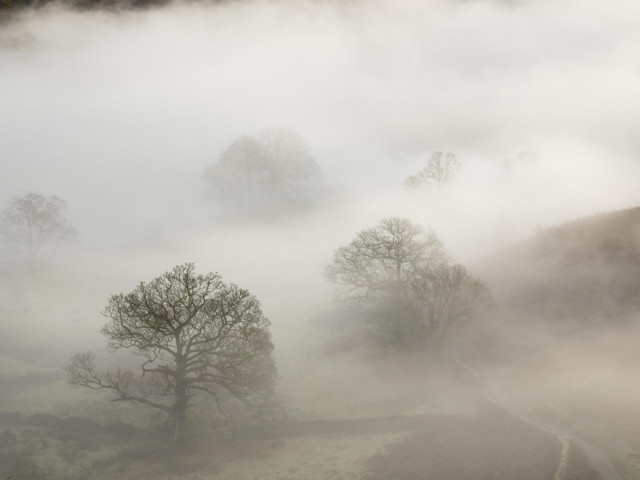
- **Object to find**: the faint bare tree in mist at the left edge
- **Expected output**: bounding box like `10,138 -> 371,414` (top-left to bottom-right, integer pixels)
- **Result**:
0,193 -> 78,268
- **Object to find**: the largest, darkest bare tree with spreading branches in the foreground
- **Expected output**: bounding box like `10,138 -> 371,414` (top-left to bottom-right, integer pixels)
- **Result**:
66,263 -> 276,441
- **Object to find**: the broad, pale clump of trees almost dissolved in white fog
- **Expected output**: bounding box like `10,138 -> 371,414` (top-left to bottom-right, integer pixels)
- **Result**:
205,128 -> 321,209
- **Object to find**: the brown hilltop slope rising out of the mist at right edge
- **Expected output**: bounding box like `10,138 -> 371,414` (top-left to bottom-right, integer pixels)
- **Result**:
476,207 -> 640,324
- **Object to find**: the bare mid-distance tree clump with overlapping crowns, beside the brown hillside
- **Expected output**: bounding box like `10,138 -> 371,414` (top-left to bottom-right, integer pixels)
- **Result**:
325,217 -> 490,349
